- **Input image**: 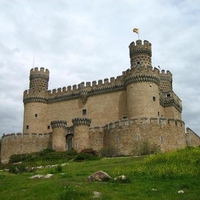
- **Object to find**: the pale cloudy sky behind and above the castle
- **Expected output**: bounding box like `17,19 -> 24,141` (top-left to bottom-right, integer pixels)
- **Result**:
0,0 -> 200,135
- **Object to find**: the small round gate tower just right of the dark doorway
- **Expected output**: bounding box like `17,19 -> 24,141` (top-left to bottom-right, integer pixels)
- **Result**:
72,118 -> 91,152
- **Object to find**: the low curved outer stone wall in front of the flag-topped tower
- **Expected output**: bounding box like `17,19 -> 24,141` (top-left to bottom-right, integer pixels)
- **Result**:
90,118 -> 186,155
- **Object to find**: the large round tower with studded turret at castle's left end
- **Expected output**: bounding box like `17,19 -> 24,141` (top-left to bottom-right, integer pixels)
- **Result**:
23,67 -> 50,133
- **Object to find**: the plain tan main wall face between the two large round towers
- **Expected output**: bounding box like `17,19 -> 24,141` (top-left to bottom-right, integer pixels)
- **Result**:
48,90 -> 127,127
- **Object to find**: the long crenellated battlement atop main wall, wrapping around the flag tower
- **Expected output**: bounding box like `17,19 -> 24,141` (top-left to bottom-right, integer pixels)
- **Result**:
27,66 -> 174,102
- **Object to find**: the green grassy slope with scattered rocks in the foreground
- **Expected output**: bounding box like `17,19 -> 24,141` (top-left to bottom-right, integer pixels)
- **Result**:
0,147 -> 200,200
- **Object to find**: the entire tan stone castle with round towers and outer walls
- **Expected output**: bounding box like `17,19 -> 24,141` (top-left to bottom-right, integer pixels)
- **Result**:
1,40 -> 200,163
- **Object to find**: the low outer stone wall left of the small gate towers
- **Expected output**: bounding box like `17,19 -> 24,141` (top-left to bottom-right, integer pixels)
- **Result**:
1,133 -> 51,164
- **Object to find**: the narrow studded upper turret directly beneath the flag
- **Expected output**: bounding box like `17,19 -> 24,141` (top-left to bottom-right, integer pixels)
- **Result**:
129,40 -> 152,68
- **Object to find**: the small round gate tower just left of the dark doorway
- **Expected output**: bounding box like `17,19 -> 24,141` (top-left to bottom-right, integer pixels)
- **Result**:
51,120 -> 67,151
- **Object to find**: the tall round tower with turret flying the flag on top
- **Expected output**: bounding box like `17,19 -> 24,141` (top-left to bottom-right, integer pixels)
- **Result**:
125,40 -> 163,118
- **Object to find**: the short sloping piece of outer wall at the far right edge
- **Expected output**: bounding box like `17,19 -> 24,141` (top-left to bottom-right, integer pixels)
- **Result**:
186,128 -> 200,147
